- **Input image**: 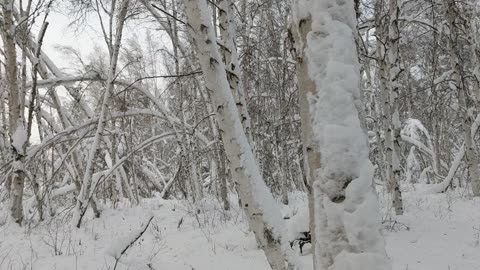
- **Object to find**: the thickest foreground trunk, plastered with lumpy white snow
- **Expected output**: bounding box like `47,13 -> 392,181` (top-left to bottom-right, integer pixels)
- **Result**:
293,0 -> 391,270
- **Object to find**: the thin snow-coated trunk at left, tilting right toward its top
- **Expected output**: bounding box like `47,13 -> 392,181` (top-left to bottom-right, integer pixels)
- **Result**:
73,0 -> 129,228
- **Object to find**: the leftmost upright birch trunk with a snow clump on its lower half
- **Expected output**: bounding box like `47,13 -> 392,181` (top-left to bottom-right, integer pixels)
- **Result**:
0,0 -> 27,224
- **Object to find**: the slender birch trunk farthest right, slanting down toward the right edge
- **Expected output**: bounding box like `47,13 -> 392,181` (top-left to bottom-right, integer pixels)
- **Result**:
444,0 -> 480,196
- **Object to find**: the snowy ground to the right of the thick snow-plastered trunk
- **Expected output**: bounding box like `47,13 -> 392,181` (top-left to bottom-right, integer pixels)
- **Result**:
384,186 -> 480,270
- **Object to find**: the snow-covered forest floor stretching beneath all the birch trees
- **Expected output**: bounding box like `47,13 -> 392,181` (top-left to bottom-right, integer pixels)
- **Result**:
0,186 -> 480,270
